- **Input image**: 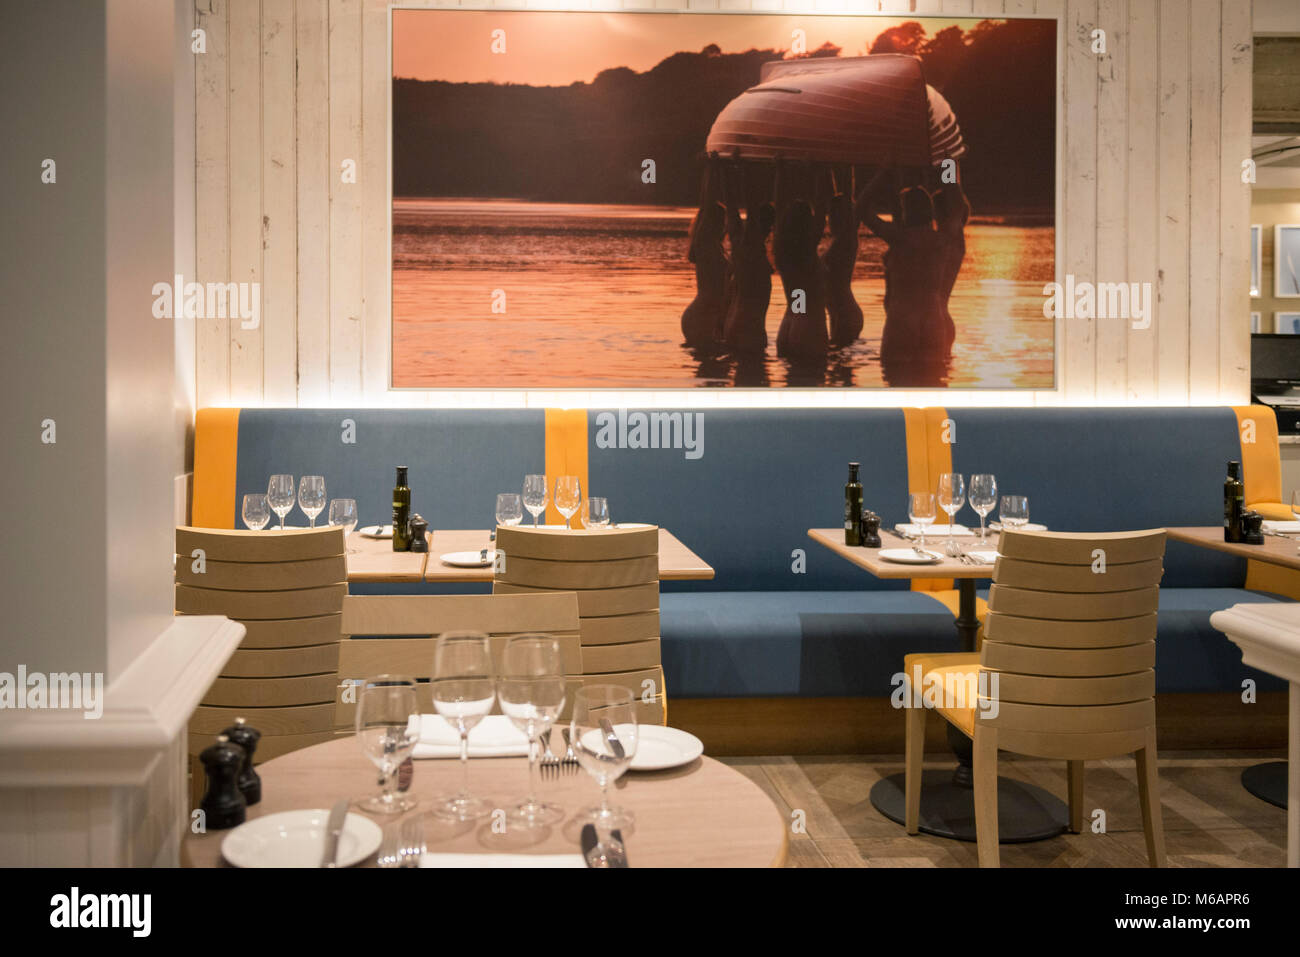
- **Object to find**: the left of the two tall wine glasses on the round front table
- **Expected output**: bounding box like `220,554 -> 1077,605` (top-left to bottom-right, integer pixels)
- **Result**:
430,631 -> 499,820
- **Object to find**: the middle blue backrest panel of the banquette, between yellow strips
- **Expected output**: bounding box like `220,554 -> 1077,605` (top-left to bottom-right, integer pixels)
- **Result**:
588,408 -> 907,590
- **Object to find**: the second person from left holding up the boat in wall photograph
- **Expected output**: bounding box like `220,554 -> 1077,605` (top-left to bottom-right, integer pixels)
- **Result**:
723,164 -> 776,355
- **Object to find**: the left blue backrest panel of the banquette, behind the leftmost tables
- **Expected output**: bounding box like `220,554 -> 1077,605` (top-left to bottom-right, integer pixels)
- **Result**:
235,408 -> 546,528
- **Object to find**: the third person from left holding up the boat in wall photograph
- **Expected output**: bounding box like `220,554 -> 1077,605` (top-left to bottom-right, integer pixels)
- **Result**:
772,163 -> 829,360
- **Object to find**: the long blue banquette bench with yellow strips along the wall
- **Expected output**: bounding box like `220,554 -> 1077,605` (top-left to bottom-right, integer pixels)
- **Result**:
192,406 -> 1300,754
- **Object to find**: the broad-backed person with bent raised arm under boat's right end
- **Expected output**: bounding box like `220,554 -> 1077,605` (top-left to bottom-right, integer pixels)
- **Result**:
857,176 -> 956,368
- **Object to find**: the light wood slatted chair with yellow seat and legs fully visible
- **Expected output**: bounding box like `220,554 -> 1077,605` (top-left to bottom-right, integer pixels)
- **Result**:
904,531 -> 1165,867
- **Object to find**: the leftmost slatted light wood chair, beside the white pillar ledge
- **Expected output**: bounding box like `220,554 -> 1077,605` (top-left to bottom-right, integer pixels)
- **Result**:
176,527 -> 347,804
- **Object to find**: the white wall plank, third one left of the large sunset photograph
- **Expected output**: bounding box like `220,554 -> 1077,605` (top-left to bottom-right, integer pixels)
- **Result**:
293,0 -> 330,407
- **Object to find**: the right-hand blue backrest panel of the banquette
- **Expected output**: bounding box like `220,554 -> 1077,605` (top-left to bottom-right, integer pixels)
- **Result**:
948,408 -> 1245,586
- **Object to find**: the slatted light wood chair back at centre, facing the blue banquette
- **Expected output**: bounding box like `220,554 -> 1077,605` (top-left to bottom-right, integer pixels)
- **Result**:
493,525 -> 667,724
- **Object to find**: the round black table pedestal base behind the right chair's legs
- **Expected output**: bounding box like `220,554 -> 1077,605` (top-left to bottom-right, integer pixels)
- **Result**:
871,770 -> 1067,844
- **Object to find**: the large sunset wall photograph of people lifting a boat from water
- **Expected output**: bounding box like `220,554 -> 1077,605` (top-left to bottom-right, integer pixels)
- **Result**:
391,9 -> 1057,390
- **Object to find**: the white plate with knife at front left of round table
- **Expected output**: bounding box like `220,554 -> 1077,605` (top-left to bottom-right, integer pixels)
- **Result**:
221,809 -> 384,867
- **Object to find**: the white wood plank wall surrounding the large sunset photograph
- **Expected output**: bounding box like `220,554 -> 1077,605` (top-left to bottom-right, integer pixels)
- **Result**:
187,0 -> 1252,407
